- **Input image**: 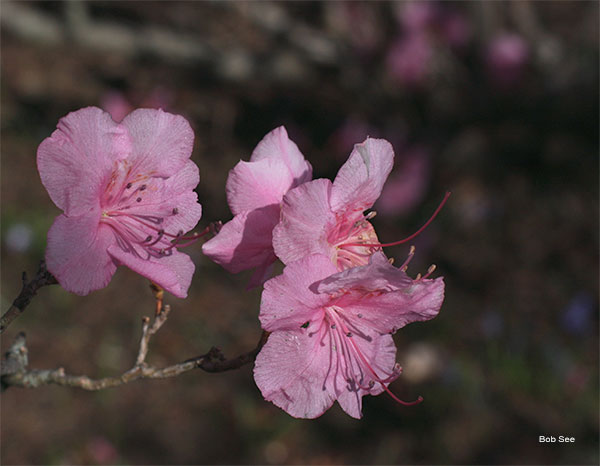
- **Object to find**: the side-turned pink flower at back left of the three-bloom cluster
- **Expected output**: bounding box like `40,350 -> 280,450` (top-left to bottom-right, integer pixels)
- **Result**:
202,126 -> 312,287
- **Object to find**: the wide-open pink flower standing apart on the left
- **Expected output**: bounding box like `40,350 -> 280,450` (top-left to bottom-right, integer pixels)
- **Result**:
37,107 -> 202,298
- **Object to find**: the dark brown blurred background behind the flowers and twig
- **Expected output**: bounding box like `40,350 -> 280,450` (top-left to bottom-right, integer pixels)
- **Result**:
0,1 -> 599,464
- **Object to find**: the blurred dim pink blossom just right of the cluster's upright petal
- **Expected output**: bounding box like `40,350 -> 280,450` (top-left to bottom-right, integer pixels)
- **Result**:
375,146 -> 431,216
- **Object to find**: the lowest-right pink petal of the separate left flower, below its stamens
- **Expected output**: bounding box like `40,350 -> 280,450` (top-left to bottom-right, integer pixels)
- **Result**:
108,245 -> 195,298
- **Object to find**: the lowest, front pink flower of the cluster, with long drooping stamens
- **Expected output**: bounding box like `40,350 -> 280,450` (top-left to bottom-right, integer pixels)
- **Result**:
254,252 -> 444,418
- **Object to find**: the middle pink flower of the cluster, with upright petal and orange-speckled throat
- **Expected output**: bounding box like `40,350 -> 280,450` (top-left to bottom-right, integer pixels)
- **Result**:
273,138 -> 394,270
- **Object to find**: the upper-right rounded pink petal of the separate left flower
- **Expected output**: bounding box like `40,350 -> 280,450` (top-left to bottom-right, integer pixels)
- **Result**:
122,108 -> 194,177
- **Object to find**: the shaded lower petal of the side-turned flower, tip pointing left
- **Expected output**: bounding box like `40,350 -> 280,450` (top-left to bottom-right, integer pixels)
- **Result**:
202,205 -> 279,275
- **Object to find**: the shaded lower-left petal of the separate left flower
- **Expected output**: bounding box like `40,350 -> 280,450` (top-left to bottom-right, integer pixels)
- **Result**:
46,210 -> 117,296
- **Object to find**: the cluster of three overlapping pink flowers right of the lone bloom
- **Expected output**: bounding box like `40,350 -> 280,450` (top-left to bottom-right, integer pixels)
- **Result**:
203,128 -> 444,418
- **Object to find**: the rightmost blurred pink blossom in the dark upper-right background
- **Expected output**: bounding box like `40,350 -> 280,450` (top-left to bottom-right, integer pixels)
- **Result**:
485,33 -> 529,86
